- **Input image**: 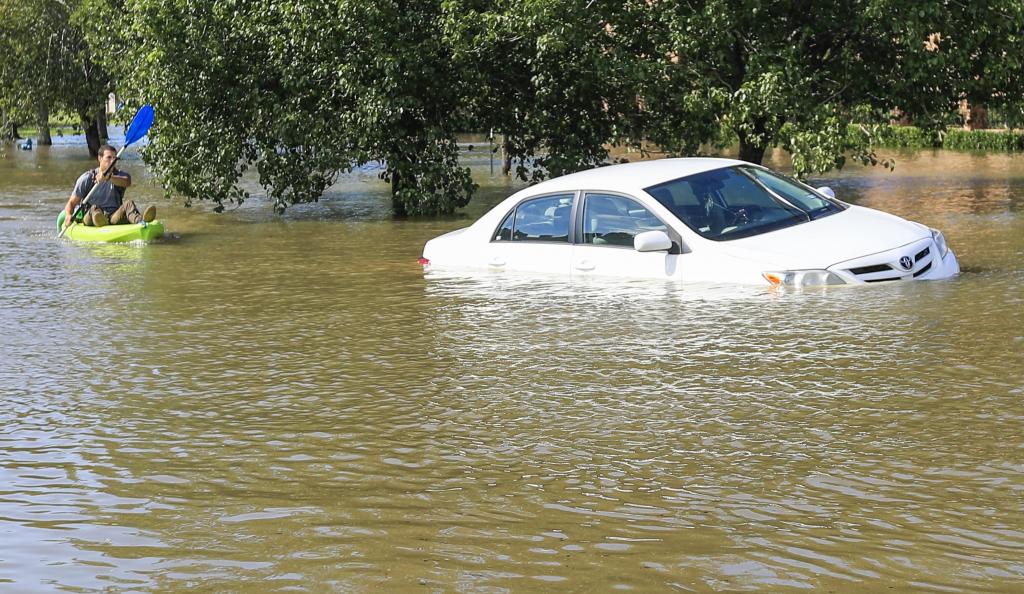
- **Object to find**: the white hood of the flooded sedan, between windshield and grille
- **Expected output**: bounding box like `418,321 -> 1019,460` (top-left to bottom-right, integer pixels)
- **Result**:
721,205 -> 930,269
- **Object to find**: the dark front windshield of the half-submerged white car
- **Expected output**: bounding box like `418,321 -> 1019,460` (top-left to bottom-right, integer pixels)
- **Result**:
645,167 -> 845,241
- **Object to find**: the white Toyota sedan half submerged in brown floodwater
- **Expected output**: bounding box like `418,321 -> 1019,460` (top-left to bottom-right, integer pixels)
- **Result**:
421,159 -> 959,286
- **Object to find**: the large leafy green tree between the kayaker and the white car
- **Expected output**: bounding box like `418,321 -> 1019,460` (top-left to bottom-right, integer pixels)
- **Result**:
101,0 -> 474,215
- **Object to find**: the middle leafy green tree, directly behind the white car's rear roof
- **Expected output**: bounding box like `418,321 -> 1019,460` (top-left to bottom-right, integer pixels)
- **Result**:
445,0 -> 643,180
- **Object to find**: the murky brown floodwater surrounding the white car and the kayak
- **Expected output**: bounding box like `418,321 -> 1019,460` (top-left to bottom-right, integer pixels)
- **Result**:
0,138 -> 1024,593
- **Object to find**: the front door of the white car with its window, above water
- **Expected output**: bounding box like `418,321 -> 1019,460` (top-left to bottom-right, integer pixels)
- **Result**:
571,192 -> 680,279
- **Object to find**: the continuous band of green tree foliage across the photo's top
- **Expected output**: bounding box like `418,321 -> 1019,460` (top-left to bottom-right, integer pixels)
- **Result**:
0,0 -> 1024,215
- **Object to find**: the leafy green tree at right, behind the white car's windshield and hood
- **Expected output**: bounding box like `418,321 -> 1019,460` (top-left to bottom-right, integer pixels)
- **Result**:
622,0 -> 1024,173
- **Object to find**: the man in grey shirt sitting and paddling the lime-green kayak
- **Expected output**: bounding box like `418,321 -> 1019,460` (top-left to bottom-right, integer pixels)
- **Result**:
65,144 -> 157,227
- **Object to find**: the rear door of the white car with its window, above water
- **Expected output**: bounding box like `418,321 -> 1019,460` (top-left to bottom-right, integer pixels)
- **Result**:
485,193 -> 575,274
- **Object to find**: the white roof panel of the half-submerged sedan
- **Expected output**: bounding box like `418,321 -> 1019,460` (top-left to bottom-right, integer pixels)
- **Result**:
524,157 -> 751,194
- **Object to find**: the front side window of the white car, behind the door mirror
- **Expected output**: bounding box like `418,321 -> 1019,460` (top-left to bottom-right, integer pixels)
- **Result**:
583,194 -> 669,248
